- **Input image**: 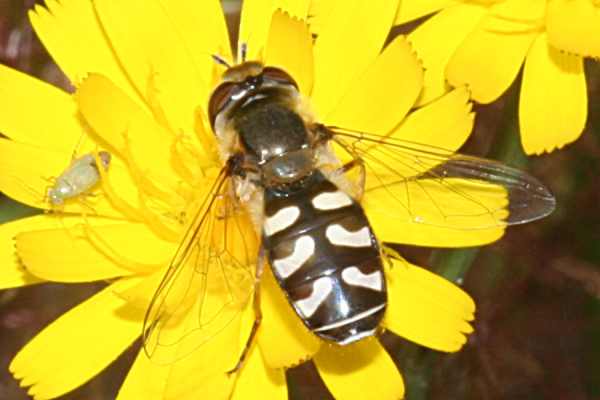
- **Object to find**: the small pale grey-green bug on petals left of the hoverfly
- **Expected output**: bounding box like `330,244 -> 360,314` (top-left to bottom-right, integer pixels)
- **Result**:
46,151 -> 111,207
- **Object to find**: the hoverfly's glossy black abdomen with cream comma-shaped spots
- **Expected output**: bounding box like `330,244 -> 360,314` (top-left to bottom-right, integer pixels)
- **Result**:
263,172 -> 387,344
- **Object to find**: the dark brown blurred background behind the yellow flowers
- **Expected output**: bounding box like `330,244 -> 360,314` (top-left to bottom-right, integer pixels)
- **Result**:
0,0 -> 600,400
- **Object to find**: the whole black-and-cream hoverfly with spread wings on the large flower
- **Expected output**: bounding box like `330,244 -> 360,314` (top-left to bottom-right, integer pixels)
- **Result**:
143,61 -> 555,367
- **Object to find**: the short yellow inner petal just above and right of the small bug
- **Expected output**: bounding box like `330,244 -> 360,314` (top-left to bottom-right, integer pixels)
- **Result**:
76,74 -> 177,187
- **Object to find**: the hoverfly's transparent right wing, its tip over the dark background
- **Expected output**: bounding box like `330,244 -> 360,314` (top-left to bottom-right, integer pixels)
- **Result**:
324,128 -> 555,230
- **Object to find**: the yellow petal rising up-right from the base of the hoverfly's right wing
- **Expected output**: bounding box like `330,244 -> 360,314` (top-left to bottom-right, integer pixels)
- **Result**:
324,36 -> 423,134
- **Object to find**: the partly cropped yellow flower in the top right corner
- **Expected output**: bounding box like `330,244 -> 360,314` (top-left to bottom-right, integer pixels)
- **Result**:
396,0 -> 600,154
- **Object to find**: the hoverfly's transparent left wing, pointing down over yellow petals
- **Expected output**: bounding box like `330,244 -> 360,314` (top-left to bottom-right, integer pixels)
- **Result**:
143,168 -> 258,364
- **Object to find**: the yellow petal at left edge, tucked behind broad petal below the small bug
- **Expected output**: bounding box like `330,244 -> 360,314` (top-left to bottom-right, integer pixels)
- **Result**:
0,215 -> 46,289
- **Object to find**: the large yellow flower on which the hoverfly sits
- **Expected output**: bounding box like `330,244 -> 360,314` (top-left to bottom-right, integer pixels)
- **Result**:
0,0 -> 502,400
